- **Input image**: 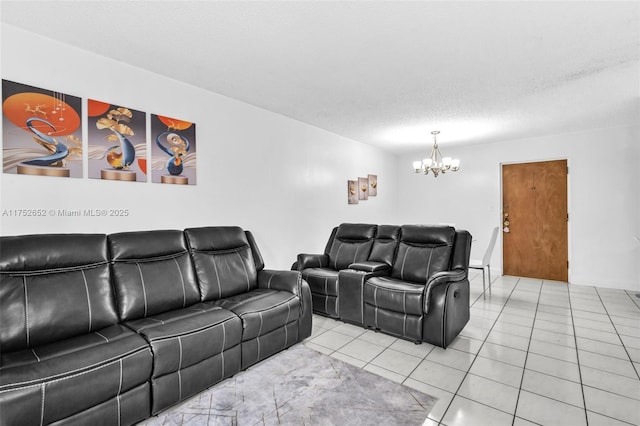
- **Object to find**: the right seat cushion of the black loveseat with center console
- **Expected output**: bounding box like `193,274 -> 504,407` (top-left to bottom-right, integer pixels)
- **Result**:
364,277 -> 424,316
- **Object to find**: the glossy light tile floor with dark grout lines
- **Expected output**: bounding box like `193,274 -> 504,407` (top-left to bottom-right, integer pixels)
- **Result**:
305,271 -> 640,426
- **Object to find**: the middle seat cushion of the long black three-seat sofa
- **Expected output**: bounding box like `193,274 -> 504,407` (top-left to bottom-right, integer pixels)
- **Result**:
125,303 -> 242,378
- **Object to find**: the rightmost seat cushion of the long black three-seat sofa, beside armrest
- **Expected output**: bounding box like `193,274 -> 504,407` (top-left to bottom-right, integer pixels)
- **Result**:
210,289 -> 300,341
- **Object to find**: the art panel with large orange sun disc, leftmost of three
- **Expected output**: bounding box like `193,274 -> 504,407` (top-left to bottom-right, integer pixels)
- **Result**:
2,80 -> 83,178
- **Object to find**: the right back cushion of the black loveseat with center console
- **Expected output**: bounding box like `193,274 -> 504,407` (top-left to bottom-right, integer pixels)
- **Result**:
391,225 -> 456,284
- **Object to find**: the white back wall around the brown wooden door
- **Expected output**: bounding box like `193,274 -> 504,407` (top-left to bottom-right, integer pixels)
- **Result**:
398,127 -> 640,290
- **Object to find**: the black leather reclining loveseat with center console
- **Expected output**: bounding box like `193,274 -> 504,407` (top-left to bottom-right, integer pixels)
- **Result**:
292,223 -> 471,348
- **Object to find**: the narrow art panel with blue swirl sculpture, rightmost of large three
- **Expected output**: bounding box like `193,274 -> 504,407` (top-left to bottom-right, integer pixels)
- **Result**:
151,114 -> 196,185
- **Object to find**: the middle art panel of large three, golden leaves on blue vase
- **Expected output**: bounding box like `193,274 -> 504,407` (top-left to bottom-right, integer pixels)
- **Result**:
87,99 -> 147,182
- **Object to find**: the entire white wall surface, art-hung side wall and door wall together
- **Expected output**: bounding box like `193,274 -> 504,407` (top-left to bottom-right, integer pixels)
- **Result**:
0,24 -> 640,290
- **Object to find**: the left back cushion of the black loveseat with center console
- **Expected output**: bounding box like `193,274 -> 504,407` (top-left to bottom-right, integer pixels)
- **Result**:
329,223 -> 376,270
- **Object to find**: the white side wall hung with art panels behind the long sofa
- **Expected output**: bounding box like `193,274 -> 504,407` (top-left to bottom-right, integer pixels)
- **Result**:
0,24 -> 397,269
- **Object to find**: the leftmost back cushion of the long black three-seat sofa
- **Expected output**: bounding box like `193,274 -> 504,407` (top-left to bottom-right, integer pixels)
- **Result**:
0,234 -> 118,352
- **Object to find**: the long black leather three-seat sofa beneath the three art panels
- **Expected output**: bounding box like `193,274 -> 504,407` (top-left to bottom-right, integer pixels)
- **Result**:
0,227 -> 311,426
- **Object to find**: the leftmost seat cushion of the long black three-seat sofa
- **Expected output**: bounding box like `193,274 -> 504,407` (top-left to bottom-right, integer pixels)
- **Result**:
0,325 -> 152,424
